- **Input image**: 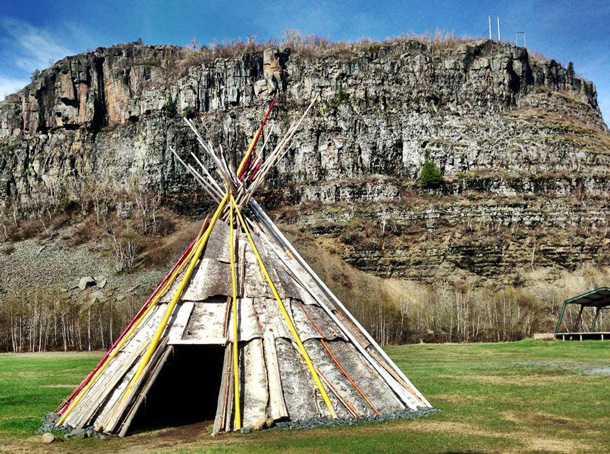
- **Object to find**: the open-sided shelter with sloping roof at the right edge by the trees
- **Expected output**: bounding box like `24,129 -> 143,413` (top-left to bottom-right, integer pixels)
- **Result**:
555,287 -> 610,341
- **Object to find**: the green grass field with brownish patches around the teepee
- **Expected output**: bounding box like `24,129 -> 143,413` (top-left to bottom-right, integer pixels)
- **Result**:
0,340 -> 610,454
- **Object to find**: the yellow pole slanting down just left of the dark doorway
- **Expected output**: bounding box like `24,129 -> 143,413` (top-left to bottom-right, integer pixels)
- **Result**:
121,192 -> 230,408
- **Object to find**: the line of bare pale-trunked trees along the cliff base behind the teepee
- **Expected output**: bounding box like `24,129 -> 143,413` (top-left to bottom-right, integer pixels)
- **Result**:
0,284 -> 610,352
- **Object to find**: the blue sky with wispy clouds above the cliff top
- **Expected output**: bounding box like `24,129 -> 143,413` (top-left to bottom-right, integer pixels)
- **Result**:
0,0 -> 610,121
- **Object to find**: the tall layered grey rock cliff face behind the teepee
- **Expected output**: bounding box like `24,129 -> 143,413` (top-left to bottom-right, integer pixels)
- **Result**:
0,41 -> 610,280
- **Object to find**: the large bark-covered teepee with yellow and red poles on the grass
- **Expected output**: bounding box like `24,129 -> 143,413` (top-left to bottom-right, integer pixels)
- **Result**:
58,99 -> 430,435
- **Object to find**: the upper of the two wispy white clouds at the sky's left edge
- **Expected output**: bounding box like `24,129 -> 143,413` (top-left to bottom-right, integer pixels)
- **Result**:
0,18 -> 74,73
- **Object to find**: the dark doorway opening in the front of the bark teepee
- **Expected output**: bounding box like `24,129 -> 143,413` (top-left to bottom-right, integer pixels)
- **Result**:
130,345 -> 225,433
